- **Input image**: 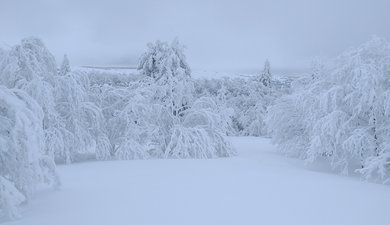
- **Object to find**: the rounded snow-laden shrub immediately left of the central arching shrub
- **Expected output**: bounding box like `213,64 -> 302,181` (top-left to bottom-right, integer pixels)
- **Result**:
108,88 -> 175,159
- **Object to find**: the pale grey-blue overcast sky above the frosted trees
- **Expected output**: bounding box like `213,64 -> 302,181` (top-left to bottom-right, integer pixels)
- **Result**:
0,0 -> 390,69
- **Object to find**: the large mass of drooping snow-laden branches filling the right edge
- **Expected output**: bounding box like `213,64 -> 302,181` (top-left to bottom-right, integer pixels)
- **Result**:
268,38 -> 390,180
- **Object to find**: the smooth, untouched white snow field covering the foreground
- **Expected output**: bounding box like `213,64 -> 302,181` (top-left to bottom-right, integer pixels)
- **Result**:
7,137 -> 390,225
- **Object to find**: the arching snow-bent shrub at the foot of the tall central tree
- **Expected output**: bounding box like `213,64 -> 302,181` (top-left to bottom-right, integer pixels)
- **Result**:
165,97 -> 235,158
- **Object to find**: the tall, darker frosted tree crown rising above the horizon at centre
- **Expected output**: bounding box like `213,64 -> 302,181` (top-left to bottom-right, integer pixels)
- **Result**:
138,39 -> 194,116
